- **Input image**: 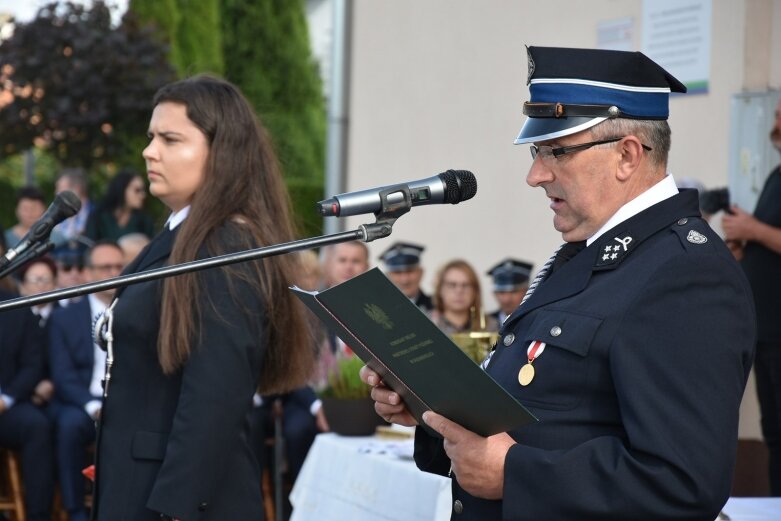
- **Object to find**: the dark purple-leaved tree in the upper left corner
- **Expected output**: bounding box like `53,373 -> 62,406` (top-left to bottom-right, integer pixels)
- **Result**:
0,0 -> 173,169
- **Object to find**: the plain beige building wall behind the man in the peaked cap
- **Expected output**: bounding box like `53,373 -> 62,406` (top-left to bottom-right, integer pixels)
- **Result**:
346,0 -> 781,438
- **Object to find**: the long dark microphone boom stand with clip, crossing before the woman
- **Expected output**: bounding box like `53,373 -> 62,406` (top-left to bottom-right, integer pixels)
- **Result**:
0,189 -> 412,312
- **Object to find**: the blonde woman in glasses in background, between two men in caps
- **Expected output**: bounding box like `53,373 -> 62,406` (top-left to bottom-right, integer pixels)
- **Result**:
431,259 -> 497,335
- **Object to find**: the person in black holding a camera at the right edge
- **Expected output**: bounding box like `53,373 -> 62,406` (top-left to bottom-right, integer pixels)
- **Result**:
721,95 -> 781,496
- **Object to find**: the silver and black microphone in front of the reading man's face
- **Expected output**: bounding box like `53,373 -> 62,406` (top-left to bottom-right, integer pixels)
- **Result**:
317,170 -> 477,217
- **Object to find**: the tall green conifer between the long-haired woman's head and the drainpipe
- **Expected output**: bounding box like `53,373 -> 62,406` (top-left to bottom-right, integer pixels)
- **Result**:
221,0 -> 326,185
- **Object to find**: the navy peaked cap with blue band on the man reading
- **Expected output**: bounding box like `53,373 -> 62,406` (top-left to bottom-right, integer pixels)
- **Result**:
515,47 -> 686,145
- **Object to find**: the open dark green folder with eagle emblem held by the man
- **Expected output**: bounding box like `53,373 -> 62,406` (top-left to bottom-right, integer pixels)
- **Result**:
291,268 -> 537,436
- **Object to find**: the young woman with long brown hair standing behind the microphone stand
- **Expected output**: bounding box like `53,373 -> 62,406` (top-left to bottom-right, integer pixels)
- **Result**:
93,76 -> 315,521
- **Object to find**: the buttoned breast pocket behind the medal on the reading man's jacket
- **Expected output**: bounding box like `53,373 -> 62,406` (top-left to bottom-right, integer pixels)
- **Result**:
516,309 -> 602,410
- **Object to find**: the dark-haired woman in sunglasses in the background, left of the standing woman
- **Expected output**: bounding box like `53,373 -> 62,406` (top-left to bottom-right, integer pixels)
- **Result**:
86,169 -> 154,242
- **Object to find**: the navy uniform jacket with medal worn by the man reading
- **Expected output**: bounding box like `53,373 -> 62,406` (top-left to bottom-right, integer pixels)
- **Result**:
415,191 -> 756,521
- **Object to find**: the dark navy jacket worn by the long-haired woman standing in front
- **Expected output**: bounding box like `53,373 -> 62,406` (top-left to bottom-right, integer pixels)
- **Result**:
92,224 -> 265,521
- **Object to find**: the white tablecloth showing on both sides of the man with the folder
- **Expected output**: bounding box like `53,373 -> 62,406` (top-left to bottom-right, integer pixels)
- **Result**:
290,434 -> 781,521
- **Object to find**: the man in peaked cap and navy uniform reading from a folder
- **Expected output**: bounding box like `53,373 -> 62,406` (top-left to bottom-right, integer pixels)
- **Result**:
361,47 -> 756,521
